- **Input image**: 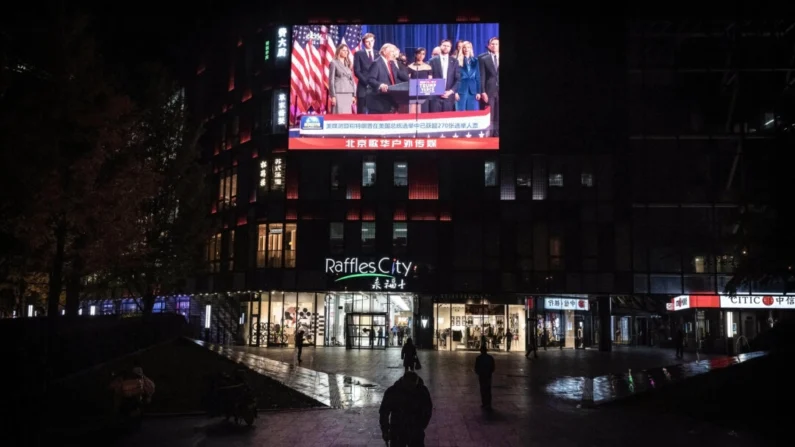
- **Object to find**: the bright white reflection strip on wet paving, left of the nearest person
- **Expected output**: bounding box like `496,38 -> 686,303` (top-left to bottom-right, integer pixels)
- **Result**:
194,340 -> 385,409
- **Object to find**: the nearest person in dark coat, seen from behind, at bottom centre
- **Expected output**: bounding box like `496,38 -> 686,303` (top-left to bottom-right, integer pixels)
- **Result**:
378,371 -> 433,447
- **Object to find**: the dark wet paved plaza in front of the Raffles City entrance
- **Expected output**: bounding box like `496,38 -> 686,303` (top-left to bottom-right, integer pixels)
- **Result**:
115,345 -> 763,447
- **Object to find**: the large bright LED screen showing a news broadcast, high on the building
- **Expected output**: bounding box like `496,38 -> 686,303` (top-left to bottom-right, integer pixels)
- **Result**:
288,23 -> 500,150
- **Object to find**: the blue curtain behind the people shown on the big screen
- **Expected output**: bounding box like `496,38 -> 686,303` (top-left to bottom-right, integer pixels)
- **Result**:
362,23 -> 500,60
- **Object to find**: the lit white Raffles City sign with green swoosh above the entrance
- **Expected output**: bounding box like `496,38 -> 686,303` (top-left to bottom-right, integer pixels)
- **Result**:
326,257 -> 416,290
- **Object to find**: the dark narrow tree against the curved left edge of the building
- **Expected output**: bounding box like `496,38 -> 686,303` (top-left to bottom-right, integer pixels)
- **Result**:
111,65 -> 207,315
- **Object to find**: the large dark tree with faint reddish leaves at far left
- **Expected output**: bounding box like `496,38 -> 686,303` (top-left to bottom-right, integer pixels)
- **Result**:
0,15 -> 156,316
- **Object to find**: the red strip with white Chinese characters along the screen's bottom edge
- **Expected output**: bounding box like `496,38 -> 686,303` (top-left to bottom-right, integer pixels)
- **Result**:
290,137 -> 500,151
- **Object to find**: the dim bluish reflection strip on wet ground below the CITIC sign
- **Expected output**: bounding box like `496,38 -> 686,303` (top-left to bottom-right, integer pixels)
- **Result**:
545,352 -> 766,404
